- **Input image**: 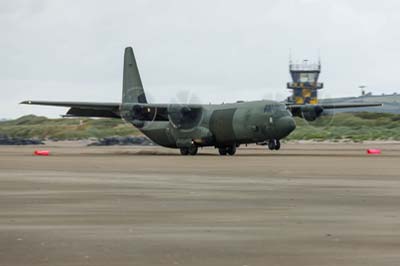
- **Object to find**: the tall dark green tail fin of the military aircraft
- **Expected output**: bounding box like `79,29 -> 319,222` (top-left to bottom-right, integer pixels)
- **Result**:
122,47 -> 147,103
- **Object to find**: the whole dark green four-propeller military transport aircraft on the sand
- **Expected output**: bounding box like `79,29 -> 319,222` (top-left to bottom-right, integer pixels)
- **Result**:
21,47 -> 380,155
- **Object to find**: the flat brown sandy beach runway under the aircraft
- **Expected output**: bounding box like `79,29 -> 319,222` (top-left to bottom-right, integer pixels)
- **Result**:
0,144 -> 400,266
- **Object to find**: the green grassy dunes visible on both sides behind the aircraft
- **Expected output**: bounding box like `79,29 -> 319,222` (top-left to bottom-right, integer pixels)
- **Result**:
0,113 -> 400,141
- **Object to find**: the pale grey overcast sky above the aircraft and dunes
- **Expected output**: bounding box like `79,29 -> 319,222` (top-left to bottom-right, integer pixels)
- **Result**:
0,0 -> 400,118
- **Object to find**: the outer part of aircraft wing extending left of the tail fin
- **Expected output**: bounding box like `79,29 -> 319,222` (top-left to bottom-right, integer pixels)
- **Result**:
21,101 -> 121,118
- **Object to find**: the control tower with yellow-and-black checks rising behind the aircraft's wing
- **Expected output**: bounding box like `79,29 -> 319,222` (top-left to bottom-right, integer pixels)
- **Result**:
287,60 -> 324,104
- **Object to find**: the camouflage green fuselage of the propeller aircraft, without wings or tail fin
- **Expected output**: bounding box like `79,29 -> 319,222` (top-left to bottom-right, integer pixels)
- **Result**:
122,101 -> 296,148
